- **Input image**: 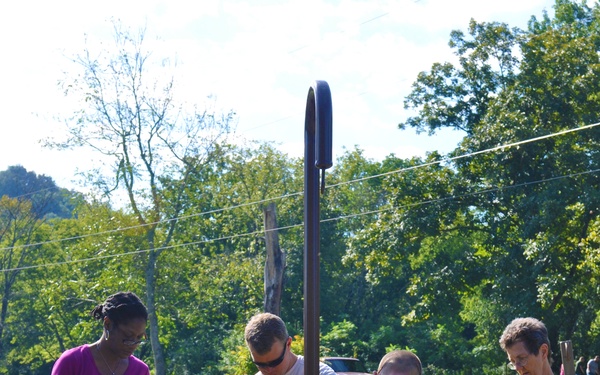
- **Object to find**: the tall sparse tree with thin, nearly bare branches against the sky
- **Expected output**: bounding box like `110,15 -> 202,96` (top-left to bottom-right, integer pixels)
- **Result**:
52,22 -> 233,375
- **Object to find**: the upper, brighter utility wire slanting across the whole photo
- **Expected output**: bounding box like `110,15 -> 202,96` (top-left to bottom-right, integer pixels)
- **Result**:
0,122 -> 600,251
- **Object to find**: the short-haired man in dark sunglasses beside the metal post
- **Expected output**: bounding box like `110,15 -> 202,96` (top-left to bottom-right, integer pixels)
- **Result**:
244,313 -> 335,375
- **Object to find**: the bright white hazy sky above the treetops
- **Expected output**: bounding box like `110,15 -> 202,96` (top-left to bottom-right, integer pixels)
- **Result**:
0,0 -> 554,188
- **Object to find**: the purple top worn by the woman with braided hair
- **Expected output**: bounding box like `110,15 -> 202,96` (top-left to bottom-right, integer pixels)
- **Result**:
52,345 -> 150,375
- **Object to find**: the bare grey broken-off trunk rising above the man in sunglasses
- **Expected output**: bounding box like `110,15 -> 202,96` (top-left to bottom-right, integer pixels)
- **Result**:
263,203 -> 285,316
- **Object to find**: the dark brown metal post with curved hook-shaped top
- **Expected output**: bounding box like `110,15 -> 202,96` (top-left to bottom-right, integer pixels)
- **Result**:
304,81 -> 333,375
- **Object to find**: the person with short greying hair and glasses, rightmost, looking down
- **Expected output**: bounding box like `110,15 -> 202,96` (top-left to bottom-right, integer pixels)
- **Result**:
500,318 -> 552,375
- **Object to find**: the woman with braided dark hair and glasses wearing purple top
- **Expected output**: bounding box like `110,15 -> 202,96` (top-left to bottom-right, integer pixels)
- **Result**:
52,292 -> 150,375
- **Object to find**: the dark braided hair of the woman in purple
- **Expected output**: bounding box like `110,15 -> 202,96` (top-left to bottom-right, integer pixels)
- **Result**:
91,292 -> 148,326
